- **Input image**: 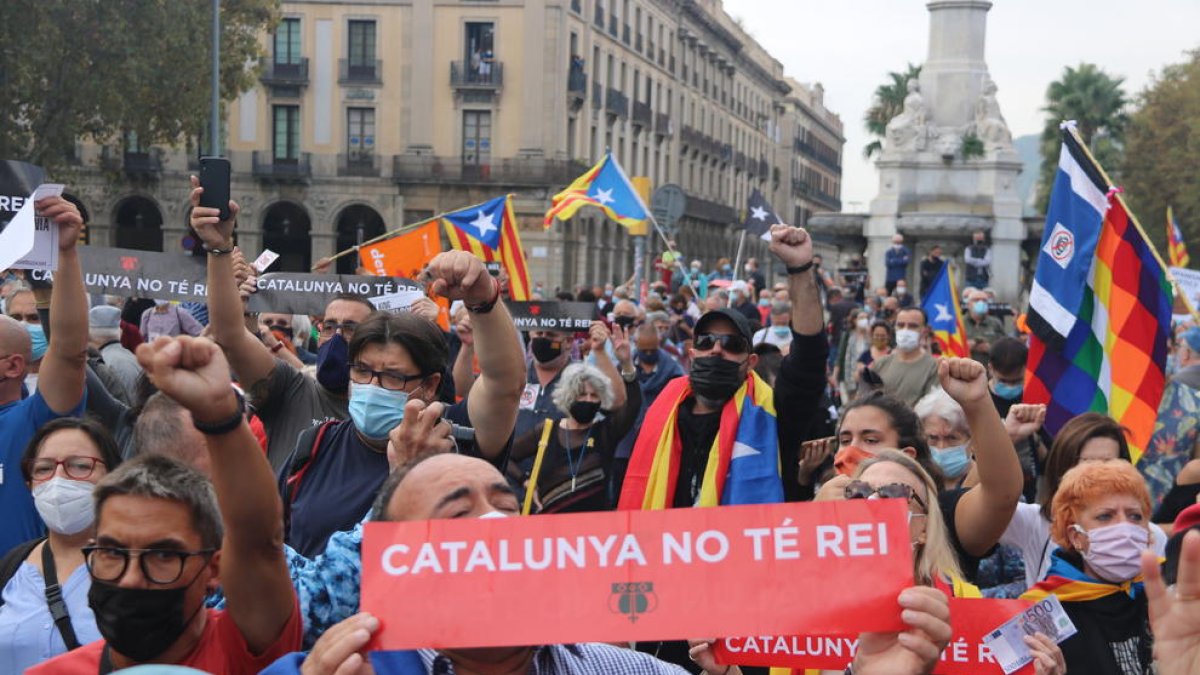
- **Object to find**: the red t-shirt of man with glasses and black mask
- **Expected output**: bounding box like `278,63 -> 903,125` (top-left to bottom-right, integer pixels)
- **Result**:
25,601 -> 304,675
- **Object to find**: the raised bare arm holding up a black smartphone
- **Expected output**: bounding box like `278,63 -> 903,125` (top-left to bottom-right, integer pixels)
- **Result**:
191,175 -> 275,393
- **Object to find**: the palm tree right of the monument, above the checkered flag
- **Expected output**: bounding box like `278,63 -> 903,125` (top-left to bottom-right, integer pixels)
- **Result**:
1038,64 -> 1129,213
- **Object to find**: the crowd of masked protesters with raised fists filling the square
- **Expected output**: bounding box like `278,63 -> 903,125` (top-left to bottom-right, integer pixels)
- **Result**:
0,186 -> 1200,675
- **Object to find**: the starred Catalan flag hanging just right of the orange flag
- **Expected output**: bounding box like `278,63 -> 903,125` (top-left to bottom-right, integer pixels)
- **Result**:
442,195 -> 530,300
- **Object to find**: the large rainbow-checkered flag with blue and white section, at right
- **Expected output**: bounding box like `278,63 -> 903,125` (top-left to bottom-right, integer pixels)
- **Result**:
1025,123 -> 1172,462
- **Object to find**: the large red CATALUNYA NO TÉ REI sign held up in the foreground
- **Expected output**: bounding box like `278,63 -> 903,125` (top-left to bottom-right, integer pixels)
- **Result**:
362,500 -> 912,650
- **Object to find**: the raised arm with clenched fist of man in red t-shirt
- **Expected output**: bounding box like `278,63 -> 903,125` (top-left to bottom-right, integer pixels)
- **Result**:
138,336 -> 296,653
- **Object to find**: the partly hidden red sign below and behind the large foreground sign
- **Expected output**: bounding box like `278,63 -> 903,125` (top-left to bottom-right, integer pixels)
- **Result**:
713,595 -> 1033,675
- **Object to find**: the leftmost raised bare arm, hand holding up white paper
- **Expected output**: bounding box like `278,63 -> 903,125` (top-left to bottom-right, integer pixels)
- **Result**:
35,197 -> 88,414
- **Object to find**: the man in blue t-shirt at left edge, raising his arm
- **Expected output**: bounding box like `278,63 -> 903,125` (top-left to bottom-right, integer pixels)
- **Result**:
0,197 -> 88,555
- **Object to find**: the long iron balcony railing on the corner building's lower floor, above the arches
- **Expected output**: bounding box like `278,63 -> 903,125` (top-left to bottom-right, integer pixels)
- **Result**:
391,155 -> 588,186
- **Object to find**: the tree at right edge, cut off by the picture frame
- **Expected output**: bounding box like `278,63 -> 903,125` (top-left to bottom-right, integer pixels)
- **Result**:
1122,50 -> 1200,262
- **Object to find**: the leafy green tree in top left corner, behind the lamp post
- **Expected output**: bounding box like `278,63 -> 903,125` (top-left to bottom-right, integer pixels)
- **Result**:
0,0 -> 280,168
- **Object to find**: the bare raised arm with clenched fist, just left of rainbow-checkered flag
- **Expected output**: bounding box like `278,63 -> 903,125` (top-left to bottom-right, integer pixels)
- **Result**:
937,358 -> 1024,556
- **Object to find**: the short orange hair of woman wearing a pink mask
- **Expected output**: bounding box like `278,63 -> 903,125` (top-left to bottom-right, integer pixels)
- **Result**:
1050,460 -> 1150,551
